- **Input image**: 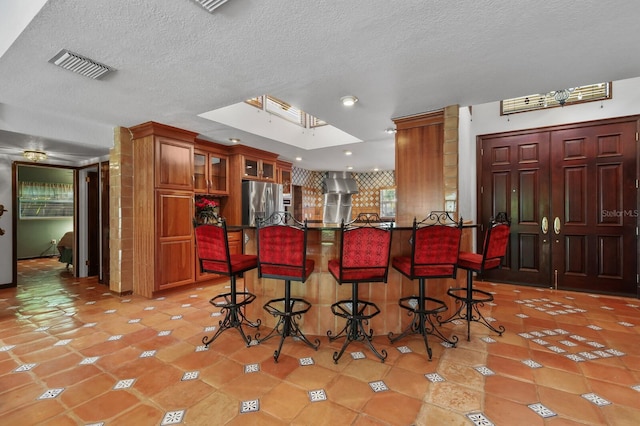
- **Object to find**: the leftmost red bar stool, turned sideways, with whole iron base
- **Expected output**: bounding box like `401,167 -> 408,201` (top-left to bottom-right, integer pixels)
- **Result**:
195,218 -> 260,346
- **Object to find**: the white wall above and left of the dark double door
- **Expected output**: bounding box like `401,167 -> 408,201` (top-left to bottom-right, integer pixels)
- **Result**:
458,78 -> 640,221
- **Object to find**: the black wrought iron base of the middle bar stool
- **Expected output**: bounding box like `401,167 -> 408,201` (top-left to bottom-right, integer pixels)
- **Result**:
327,283 -> 387,364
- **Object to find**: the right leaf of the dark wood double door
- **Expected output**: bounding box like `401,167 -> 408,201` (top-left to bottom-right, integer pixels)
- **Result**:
551,120 -> 637,295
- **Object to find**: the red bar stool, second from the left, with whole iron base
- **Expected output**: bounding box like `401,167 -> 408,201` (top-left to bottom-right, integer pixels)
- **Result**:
256,212 -> 320,362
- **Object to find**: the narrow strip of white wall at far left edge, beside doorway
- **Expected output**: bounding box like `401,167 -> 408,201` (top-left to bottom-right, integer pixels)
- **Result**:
0,155 -> 14,285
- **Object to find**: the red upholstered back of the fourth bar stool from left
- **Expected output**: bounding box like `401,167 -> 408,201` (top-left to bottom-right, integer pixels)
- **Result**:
411,224 -> 462,278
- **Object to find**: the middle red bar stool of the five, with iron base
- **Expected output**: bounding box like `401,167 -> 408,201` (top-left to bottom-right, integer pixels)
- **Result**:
327,213 -> 391,363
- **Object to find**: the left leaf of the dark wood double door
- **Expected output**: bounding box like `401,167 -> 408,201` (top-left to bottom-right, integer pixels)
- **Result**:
478,133 -> 551,285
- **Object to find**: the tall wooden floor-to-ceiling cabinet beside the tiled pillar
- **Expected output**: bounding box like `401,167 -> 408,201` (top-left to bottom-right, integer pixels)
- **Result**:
129,122 -> 197,297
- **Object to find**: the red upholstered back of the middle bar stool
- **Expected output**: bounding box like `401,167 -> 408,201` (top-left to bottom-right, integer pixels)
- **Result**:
337,225 -> 391,282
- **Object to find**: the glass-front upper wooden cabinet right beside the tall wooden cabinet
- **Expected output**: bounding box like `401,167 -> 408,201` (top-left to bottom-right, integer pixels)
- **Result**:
193,141 -> 229,195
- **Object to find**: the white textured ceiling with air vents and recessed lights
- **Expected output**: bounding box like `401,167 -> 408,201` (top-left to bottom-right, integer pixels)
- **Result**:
0,0 -> 640,171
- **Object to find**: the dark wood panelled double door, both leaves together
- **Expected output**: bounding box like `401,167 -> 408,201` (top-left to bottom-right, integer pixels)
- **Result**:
478,117 -> 640,297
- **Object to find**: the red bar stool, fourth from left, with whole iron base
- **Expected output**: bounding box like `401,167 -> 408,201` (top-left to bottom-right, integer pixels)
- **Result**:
389,212 -> 462,361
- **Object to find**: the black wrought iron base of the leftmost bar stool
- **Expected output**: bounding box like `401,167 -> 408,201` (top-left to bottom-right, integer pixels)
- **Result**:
202,276 -> 261,346
